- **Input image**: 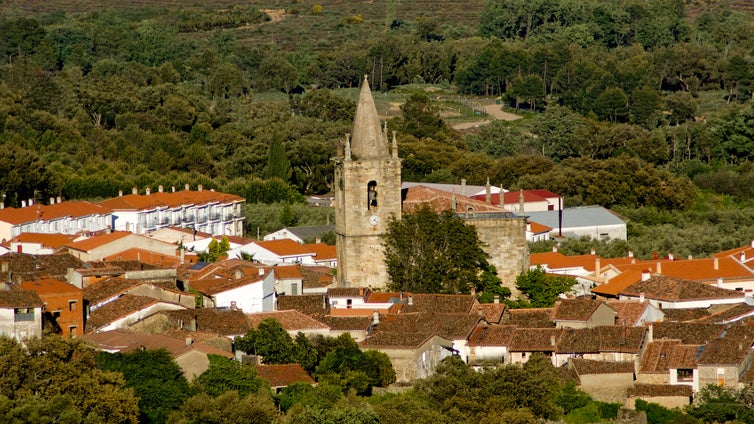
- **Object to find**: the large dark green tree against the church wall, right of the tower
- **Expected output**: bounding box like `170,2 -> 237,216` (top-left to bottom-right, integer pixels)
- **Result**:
383,205 -> 490,293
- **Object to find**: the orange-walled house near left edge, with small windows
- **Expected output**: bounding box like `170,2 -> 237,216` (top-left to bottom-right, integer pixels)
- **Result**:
21,278 -> 84,337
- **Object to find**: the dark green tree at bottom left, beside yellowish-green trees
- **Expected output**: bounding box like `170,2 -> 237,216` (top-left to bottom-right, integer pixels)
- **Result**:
97,349 -> 191,423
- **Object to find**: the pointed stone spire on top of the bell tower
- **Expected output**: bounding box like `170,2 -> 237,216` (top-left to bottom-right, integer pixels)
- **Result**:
351,75 -> 388,160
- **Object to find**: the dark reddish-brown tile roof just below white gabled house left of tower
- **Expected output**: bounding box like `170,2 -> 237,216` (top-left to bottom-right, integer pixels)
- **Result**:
160,308 -> 251,336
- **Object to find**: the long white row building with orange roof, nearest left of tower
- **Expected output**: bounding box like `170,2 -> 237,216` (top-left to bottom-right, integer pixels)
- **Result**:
98,184 -> 245,236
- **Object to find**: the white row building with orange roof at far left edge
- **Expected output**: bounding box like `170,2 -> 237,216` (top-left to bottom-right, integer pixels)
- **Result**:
0,198 -> 112,241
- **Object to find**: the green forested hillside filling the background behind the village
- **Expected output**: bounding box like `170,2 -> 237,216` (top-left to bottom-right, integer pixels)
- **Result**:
0,0 -> 754,255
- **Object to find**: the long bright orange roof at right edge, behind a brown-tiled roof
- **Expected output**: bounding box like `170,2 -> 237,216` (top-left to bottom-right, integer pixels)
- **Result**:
616,257 -> 754,283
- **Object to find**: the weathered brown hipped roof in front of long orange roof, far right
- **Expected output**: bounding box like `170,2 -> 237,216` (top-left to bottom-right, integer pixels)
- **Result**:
620,275 -> 743,302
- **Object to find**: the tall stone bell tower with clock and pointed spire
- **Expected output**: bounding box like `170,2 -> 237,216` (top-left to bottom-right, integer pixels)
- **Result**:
334,76 -> 401,289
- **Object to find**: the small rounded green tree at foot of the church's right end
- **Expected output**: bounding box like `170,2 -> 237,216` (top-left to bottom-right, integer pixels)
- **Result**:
510,267 -> 576,308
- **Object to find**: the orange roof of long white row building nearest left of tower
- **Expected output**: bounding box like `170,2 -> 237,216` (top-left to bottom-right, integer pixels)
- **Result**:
98,190 -> 244,211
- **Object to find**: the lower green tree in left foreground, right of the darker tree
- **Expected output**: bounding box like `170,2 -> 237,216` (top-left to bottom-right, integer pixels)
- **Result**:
194,355 -> 269,397
